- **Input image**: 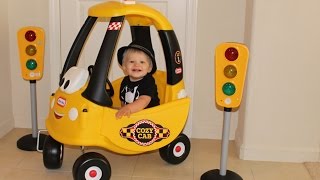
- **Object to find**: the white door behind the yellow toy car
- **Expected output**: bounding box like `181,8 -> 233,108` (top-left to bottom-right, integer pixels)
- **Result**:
49,0 -> 197,135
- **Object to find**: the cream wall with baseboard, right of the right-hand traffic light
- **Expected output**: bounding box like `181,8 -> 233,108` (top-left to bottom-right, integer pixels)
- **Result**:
237,0 -> 320,162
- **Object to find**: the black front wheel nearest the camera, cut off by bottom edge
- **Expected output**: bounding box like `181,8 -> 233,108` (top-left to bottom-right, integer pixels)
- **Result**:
72,152 -> 111,180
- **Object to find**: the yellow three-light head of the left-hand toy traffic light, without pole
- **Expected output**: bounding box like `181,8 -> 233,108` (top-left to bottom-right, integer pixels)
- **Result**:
18,26 -> 44,80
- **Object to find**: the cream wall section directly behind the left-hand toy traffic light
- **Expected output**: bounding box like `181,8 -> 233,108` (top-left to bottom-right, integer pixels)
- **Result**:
8,0 -> 51,128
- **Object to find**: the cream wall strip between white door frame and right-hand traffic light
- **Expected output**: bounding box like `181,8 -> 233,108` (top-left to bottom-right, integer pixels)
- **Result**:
192,0 -> 245,139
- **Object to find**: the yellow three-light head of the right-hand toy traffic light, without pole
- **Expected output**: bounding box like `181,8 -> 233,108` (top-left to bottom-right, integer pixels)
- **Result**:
215,43 -> 249,108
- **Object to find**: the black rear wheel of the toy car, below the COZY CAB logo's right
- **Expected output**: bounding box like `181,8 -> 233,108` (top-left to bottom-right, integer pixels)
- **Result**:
159,134 -> 190,164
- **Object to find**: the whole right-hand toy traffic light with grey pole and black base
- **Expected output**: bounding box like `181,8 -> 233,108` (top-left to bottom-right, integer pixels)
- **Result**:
201,43 -> 249,180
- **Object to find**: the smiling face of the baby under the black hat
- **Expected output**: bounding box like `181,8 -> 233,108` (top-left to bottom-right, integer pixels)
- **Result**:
122,51 -> 152,81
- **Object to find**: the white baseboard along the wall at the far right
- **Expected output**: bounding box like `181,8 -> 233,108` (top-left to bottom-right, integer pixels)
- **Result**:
236,145 -> 320,163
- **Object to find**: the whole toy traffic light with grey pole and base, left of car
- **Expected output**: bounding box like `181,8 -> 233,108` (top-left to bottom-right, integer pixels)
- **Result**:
17,26 -> 45,151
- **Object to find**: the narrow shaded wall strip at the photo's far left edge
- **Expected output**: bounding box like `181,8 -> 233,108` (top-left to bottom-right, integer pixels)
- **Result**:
0,0 -> 14,137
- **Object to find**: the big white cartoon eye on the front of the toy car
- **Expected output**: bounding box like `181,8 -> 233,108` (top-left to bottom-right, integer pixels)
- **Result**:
60,66 -> 89,94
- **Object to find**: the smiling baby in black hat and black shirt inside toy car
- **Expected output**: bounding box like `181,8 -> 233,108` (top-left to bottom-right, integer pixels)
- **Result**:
116,41 -> 160,119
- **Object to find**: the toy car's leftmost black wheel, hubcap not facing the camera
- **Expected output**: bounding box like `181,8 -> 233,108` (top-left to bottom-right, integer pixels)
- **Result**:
42,136 -> 64,169
